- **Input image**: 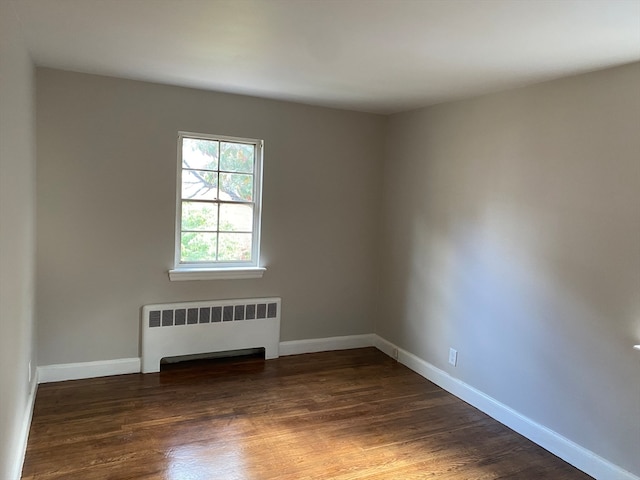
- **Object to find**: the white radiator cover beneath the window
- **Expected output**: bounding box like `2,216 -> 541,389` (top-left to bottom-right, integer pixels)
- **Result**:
142,298 -> 281,373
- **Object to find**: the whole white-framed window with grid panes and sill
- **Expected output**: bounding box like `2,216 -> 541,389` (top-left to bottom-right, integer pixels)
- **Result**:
169,132 -> 264,280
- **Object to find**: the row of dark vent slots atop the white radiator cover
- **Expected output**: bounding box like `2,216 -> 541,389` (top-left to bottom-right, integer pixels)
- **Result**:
148,303 -> 278,327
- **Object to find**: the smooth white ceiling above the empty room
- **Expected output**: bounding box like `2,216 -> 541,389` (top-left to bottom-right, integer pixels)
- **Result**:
10,0 -> 640,113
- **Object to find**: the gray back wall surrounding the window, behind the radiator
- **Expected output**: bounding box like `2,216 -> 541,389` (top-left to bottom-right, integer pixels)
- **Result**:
37,69 -> 384,365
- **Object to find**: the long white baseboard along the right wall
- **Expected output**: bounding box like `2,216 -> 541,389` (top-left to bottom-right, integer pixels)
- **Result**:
373,335 -> 640,480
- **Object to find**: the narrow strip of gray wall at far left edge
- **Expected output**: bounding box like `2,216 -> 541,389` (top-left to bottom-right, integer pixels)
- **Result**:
0,1 -> 36,480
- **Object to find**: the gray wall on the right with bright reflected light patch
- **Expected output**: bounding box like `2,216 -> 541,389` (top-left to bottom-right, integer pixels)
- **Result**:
376,64 -> 640,475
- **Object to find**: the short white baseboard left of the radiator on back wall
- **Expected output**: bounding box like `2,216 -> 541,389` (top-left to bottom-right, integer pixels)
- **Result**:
38,358 -> 140,383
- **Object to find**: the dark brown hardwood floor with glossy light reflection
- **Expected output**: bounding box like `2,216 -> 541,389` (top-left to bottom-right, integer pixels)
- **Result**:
22,348 -> 591,480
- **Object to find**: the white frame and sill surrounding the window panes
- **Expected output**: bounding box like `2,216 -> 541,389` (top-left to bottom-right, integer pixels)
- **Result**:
169,131 -> 266,281
